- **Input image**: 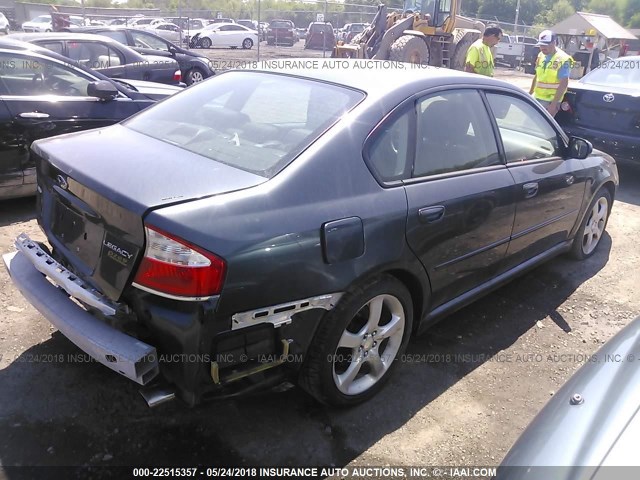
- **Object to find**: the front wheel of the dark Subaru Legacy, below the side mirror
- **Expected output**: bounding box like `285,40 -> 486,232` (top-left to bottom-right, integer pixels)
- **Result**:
571,188 -> 613,260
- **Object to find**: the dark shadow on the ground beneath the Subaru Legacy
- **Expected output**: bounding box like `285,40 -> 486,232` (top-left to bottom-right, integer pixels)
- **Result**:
0,235 -> 611,470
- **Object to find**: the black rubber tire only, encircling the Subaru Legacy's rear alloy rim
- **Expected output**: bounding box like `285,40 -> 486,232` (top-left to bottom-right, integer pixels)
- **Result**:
303,275 -> 413,405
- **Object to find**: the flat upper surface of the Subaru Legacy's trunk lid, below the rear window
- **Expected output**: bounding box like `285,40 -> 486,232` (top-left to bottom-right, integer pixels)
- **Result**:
32,124 -> 267,216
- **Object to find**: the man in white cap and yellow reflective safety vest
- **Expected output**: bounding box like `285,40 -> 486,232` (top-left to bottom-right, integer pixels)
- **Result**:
529,30 -> 574,116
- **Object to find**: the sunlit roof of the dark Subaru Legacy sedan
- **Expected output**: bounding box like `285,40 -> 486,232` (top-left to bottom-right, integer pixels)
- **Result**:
246,58 -> 522,96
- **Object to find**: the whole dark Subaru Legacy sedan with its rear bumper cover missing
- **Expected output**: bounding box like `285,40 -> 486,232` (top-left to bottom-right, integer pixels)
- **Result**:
4,60 -> 618,405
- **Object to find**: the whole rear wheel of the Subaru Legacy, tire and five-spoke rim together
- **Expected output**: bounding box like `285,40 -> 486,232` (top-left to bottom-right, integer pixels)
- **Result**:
299,275 -> 413,405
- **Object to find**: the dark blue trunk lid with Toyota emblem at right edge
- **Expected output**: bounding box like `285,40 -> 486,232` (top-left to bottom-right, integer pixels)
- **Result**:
561,84 -> 640,134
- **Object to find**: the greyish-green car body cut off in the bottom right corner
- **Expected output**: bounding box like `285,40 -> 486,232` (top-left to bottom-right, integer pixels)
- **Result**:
496,317 -> 640,480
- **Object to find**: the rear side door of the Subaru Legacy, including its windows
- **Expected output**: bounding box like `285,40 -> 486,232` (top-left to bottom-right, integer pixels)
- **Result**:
370,89 -> 515,307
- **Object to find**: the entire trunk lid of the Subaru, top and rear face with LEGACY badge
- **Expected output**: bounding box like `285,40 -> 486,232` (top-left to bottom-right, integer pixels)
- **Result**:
32,125 -> 267,301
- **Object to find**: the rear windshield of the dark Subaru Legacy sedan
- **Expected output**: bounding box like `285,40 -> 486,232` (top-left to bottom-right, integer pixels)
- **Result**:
123,71 -> 364,178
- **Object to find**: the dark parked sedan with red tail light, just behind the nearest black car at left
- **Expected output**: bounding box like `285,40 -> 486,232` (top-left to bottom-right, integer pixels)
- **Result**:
7,32 -> 182,85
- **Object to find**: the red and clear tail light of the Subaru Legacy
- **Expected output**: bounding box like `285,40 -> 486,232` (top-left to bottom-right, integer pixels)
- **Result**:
134,225 -> 226,298
